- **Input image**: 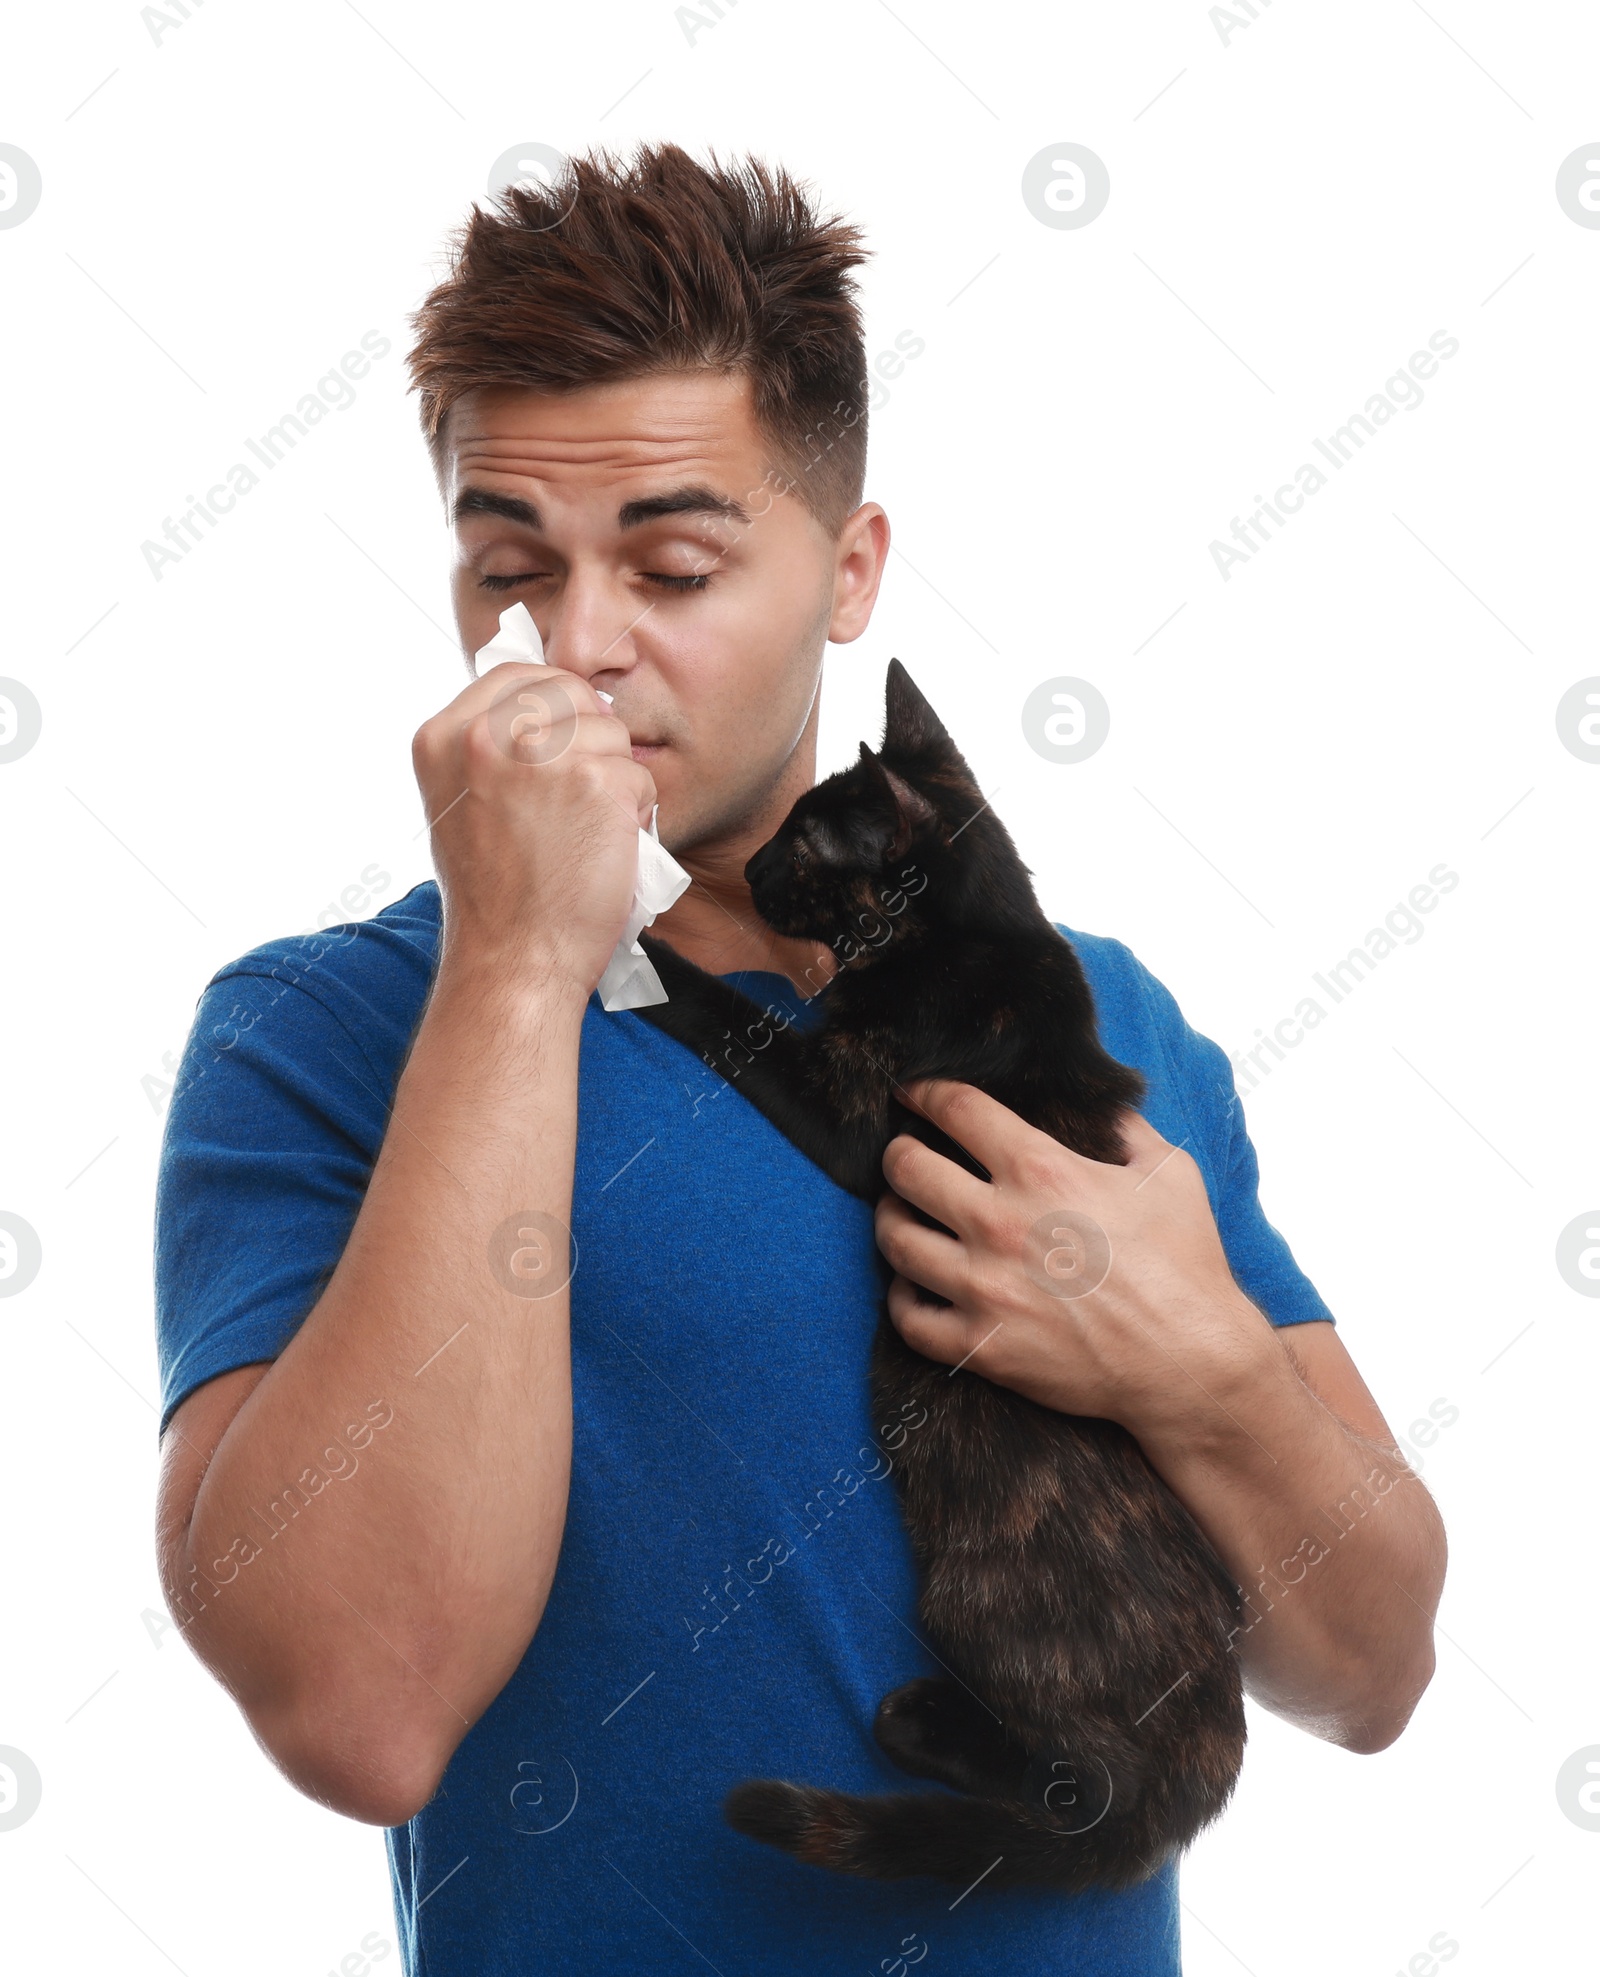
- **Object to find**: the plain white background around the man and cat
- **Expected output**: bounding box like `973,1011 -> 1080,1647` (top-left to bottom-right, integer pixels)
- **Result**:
0,0 -> 1600,1977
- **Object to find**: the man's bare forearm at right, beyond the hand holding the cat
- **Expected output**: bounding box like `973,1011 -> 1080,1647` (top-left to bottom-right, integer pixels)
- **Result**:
1127,1317 -> 1446,1752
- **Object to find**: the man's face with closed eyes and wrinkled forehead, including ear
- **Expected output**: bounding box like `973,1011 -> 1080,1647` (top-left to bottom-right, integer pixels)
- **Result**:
445,372 -> 888,852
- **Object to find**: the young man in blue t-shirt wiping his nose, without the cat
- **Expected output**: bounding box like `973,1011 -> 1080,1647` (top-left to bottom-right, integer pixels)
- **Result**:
156,146 -> 1444,1977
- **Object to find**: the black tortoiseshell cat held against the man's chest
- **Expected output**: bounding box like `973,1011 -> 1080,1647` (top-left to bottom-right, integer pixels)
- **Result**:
641,660 -> 1244,1890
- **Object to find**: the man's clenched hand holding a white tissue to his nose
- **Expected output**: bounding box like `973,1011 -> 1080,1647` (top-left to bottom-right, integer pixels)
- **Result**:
411,632 -> 657,1002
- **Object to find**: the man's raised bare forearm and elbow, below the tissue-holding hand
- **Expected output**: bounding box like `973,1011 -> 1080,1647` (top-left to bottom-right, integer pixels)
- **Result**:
166,957 -> 583,1823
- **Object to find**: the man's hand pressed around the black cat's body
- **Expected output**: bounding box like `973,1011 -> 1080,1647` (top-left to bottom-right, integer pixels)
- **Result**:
876,1079 -> 1270,1435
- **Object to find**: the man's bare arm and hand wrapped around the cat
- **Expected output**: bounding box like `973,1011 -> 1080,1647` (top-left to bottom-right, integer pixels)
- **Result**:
878,1083 -> 1446,1752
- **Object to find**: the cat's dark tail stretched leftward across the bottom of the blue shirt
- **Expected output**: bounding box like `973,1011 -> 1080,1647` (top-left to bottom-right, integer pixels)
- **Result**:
722,1777 -> 1167,1894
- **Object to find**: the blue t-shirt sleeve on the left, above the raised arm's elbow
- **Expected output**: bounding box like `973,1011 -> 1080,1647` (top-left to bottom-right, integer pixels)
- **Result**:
154,969 -> 388,1429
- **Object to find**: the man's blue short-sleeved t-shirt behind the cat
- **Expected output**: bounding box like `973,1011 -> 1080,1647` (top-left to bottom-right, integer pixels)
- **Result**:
156,882 -> 1331,1977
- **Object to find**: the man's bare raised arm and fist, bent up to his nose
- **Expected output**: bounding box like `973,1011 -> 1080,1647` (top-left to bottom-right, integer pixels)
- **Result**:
158,648 -> 655,1825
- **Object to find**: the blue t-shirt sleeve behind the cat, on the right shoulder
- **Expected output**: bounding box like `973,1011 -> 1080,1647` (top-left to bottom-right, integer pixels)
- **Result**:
1108,943 -> 1333,1325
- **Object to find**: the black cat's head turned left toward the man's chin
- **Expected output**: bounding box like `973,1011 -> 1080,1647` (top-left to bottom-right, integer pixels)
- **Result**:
744,658 -> 1032,965
